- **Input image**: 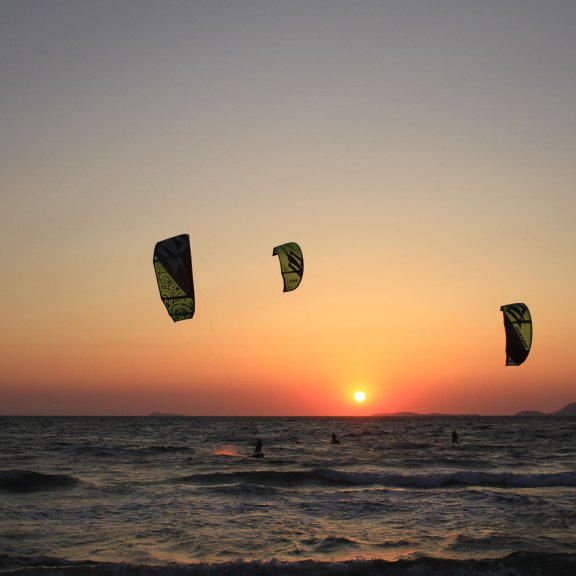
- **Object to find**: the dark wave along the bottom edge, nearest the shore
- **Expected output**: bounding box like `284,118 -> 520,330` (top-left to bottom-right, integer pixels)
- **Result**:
0,552 -> 576,576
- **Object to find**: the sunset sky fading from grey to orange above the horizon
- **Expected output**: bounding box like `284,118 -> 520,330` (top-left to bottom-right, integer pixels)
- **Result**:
0,0 -> 576,416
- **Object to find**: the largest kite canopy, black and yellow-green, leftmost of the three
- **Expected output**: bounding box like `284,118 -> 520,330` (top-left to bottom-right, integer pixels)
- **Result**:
153,234 -> 195,322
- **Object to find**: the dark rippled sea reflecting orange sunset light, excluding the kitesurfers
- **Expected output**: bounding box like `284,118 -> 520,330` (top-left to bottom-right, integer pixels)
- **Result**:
0,416 -> 576,576
